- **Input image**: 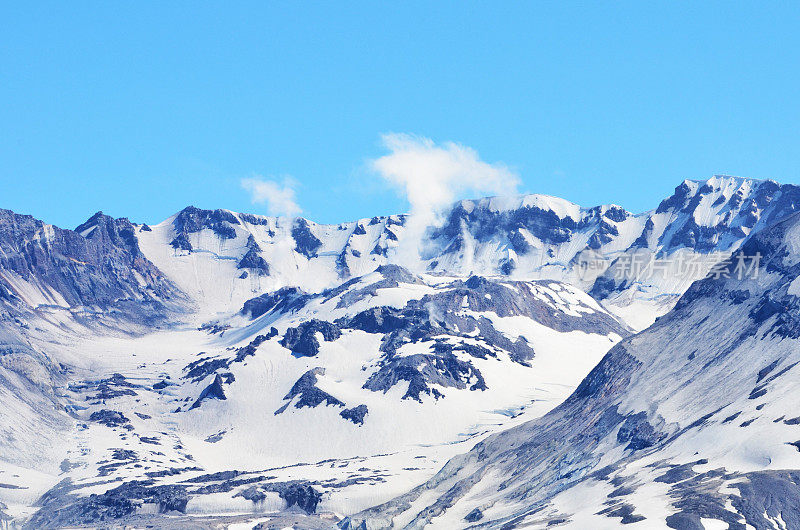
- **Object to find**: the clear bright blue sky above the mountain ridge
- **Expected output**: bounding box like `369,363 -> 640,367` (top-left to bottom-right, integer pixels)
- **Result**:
0,1 -> 800,227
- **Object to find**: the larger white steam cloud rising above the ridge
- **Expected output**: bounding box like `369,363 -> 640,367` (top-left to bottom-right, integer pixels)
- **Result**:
371,133 -> 520,266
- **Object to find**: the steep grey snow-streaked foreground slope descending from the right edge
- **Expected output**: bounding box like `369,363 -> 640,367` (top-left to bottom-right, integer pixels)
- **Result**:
342,201 -> 800,529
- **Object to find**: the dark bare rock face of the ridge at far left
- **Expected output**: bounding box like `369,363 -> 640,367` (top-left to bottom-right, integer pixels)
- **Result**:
0,210 -> 183,323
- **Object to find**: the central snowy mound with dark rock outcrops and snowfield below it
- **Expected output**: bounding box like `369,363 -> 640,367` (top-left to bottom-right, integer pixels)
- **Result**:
20,266 -> 628,526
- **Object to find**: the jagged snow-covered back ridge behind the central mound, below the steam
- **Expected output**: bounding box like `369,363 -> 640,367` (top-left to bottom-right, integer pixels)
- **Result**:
128,176 -> 800,329
